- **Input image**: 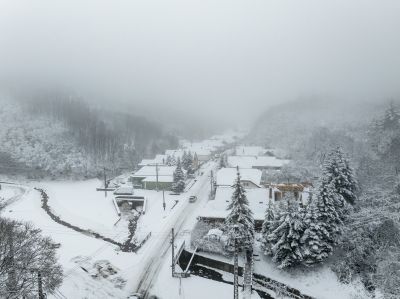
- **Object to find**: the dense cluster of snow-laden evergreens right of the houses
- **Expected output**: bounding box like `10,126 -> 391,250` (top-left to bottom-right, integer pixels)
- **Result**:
262,148 -> 357,268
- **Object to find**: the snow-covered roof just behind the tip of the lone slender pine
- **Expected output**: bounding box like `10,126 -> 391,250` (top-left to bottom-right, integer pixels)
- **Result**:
217,168 -> 262,186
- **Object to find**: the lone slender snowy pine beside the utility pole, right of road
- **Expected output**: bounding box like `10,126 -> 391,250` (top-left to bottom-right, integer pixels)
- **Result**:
224,169 -> 254,250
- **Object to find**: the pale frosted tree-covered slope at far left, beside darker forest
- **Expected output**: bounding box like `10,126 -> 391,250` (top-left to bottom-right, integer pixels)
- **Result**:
0,101 -> 88,176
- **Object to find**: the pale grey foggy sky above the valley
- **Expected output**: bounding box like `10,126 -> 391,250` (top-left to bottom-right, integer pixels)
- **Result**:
0,0 -> 400,124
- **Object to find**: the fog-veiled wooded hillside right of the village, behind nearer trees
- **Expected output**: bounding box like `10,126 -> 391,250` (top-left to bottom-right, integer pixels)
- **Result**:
249,98 -> 384,157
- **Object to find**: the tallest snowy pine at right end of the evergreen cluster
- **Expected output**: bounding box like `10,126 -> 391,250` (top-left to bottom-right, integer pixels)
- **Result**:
322,147 -> 358,212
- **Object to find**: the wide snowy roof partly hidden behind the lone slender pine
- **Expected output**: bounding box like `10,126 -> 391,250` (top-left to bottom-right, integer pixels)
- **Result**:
200,187 -> 269,220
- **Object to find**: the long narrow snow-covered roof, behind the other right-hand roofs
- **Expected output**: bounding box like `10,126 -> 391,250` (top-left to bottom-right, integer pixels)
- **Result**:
228,156 -> 290,168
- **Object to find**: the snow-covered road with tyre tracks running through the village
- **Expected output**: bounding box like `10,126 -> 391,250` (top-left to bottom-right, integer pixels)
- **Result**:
132,161 -> 217,298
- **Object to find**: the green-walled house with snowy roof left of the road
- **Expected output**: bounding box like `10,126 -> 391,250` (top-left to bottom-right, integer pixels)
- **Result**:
130,165 -> 176,190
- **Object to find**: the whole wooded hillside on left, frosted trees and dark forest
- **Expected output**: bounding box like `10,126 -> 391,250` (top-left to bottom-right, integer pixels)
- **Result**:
0,94 -> 177,178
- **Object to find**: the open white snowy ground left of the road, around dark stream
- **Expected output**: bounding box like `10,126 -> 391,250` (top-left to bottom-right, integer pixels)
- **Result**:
1,164 -> 225,299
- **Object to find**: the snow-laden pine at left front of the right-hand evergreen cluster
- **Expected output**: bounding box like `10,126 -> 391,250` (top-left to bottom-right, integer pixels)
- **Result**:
270,193 -> 304,269
